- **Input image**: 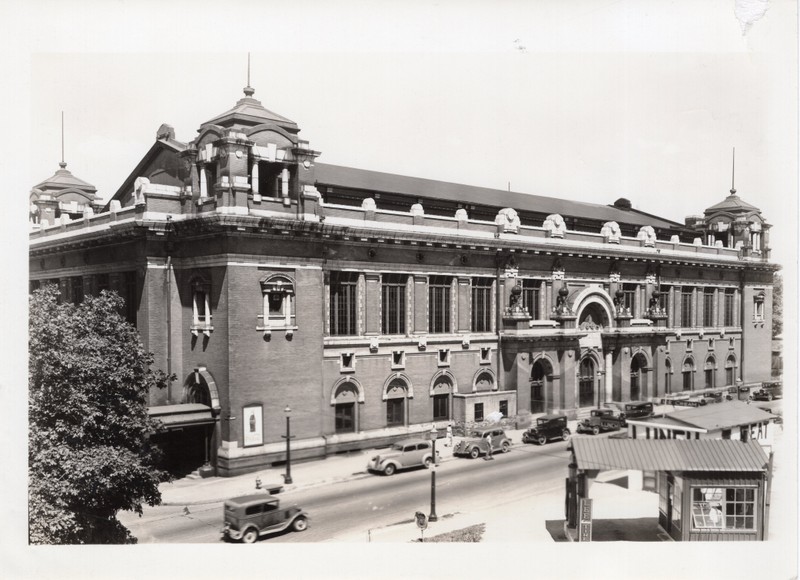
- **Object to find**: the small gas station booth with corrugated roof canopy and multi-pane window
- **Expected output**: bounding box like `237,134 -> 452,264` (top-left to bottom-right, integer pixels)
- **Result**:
566,438 -> 772,541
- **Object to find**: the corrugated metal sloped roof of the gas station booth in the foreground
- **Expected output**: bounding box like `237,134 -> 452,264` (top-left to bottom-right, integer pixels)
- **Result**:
571,437 -> 767,472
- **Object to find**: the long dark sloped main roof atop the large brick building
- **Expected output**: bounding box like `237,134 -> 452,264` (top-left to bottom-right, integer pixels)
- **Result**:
315,163 -> 683,229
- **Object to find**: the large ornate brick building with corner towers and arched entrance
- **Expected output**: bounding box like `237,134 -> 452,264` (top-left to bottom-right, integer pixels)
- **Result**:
30,82 -> 776,475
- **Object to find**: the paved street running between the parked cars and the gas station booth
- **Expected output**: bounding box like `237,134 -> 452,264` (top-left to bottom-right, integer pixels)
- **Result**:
120,442 -> 568,543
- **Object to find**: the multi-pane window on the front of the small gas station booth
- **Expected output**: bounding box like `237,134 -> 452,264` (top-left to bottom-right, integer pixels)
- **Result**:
692,487 -> 756,531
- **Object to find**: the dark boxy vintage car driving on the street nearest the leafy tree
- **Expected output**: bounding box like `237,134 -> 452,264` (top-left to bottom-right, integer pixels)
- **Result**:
222,493 -> 309,544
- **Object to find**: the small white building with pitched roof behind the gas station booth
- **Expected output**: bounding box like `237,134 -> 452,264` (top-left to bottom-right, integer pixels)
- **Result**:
628,401 -> 775,445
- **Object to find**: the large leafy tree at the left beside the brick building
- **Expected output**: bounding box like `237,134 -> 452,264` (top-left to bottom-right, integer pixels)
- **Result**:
28,285 -> 173,544
